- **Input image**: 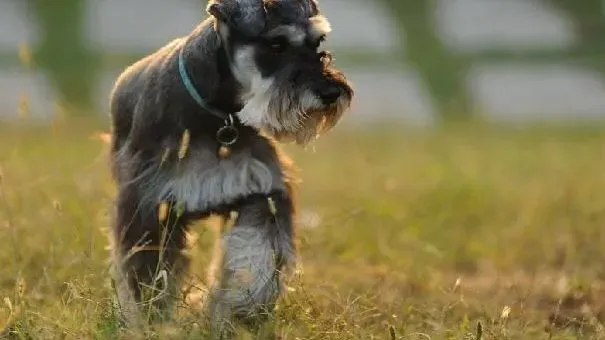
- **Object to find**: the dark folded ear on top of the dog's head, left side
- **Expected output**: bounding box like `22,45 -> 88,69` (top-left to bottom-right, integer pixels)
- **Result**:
206,0 -> 265,36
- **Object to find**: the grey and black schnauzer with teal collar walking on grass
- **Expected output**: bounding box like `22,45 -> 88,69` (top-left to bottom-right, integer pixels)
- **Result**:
109,0 -> 354,339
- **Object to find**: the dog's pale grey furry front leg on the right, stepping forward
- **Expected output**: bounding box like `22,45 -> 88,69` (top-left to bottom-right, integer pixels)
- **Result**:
207,192 -> 295,339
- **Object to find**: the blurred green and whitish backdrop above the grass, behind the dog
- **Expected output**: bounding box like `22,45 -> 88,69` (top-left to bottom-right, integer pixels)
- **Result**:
0,0 -> 605,125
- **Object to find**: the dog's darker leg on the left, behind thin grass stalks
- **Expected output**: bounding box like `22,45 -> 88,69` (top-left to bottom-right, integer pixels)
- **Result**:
112,187 -> 189,327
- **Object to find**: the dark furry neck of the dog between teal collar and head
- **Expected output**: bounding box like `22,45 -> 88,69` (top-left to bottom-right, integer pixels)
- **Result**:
181,18 -> 242,120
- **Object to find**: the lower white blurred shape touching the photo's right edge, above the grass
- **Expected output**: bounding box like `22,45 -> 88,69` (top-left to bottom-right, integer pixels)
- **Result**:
468,64 -> 605,121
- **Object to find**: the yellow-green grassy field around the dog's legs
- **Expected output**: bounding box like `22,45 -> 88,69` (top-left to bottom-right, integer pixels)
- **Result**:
0,116 -> 605,339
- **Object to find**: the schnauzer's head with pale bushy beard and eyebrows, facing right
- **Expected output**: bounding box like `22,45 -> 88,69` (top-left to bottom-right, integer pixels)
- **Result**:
207,0 -> 353,144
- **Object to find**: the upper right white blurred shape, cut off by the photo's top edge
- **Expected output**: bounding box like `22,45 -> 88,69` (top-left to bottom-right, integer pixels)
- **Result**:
435,0 -> 577,51
